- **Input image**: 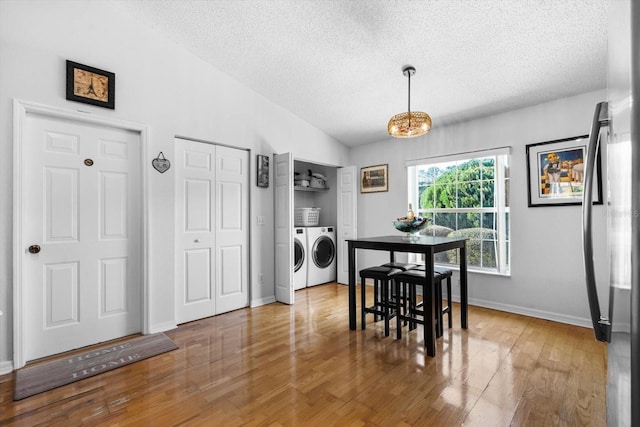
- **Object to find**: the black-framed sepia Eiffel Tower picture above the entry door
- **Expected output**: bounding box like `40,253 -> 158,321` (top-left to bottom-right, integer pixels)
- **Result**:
67,61 -> 116,110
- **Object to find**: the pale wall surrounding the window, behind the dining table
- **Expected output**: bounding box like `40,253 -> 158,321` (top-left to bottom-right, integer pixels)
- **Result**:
351,90 -> 608,326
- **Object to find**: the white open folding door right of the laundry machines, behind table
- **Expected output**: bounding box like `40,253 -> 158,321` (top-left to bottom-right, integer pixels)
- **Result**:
337,166 -> 358,284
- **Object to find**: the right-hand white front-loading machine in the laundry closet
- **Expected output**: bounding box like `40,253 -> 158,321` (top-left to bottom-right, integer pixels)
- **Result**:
307,227 -> 337,286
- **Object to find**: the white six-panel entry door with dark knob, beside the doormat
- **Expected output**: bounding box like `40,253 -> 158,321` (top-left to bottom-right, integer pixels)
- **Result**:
21,114 -> 142,361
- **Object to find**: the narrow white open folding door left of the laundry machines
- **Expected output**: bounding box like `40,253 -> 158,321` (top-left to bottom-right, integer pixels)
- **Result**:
273,153 -> 295,304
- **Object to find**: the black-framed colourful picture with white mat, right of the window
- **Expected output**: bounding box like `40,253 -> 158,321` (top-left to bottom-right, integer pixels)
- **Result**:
526,135 -> 602,207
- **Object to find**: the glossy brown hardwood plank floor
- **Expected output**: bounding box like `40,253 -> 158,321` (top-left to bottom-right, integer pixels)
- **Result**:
0,284 -> 606,426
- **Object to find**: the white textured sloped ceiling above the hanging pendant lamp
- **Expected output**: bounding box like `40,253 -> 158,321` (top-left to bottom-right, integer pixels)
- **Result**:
113,0 -> 608,146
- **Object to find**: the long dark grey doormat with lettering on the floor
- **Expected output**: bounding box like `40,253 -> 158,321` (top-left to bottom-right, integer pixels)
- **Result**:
13,333 -> 178,400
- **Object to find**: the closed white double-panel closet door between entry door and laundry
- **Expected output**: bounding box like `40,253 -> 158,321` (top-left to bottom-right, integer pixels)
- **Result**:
175,138 -> 249,323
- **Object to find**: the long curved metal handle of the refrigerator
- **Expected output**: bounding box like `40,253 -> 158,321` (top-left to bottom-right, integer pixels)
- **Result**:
582,102 -> 611,342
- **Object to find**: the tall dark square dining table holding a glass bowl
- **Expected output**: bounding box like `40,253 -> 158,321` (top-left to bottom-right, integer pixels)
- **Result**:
347,235 -> 469,357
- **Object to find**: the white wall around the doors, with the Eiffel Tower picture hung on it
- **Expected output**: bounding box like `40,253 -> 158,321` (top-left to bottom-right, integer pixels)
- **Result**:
0,0 -> 349,373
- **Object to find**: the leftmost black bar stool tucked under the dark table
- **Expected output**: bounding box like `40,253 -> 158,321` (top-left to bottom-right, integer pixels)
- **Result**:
360,265 -> 402,337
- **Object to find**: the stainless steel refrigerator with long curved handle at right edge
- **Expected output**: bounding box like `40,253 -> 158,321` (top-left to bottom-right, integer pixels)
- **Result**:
582,0 -> 640,427
